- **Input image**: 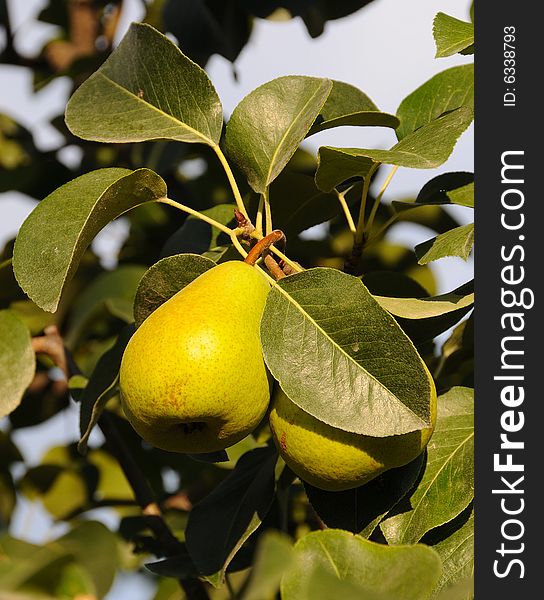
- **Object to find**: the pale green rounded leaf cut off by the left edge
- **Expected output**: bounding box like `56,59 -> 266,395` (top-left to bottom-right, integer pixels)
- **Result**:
0,310 -> 36,418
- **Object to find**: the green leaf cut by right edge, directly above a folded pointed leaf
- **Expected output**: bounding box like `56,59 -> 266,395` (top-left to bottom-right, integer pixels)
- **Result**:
396,64 -> 474,140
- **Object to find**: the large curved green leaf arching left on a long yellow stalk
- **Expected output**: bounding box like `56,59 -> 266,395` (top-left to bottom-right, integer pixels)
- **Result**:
13,169 -> 166,312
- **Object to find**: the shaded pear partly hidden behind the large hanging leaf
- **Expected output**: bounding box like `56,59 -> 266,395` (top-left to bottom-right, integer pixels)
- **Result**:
270,386 -> 436,491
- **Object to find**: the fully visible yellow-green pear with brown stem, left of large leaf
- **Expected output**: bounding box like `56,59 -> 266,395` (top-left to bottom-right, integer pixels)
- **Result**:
119,261 -> 270,453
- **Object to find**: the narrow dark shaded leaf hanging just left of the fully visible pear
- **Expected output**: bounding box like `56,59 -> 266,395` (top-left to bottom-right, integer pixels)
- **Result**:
77,325 -> 134,454
